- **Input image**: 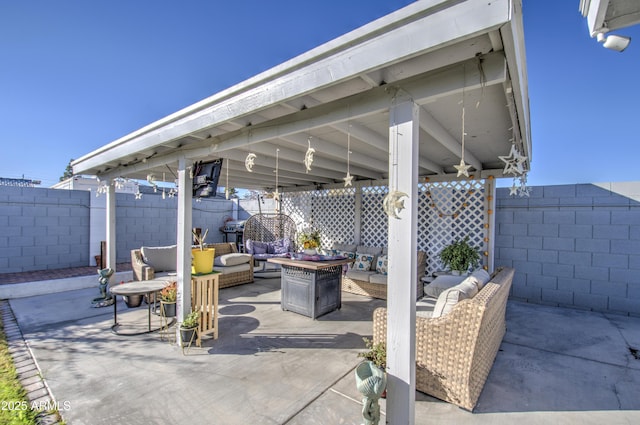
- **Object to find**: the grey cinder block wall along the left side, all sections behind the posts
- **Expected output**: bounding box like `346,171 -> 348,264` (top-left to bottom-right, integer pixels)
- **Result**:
0,186 -> 233,273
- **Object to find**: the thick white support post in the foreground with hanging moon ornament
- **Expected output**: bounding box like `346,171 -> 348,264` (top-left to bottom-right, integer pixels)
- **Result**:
387,99 -> 419,425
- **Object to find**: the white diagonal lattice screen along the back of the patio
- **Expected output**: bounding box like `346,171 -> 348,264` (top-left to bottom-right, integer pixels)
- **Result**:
282,180 -> 488,274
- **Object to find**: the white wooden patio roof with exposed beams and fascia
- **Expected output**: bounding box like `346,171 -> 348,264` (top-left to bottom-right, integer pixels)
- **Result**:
73,0 -> 531,191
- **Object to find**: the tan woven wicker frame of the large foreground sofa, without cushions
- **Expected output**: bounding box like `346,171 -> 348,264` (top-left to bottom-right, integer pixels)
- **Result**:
373,268 -> 514,411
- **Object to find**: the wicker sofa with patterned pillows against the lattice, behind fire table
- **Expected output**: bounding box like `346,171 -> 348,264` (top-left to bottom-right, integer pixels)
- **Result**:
342,249 -> 427,300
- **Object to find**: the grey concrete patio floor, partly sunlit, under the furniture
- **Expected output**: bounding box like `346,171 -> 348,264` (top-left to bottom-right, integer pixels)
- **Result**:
5,279 -> 640,425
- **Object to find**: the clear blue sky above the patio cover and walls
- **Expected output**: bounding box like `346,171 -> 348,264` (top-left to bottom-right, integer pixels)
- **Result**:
0,0 -> 640,186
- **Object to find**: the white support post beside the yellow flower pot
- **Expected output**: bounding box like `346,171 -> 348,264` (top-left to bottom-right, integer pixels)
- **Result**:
176,157 -> 193,338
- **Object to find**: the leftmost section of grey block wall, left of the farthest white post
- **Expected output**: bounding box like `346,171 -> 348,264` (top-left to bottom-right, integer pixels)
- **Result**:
0,186 -> 89,273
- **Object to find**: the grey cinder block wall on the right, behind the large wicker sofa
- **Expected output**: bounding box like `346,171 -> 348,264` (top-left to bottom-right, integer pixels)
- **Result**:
495,184 -> 640,315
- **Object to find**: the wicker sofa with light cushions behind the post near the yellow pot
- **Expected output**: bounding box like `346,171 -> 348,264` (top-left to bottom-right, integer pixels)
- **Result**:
131,242 -> 253,289
